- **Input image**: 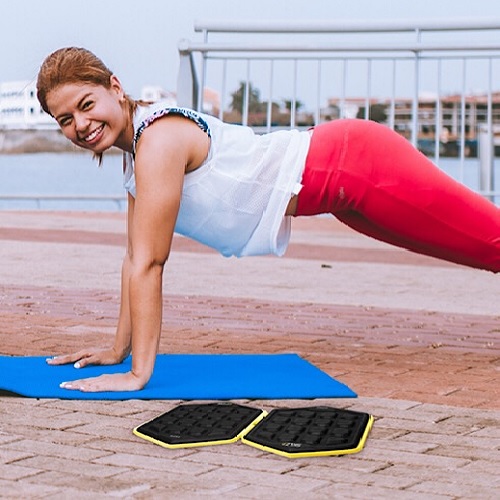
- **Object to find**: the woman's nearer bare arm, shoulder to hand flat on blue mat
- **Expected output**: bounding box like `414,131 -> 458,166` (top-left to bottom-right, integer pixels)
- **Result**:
57,117 -> 209,391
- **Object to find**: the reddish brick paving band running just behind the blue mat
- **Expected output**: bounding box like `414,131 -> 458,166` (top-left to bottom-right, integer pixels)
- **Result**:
0,287 -> 500,409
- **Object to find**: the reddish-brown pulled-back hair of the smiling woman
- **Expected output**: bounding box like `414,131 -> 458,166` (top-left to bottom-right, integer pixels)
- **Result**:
36,47 -> 138,116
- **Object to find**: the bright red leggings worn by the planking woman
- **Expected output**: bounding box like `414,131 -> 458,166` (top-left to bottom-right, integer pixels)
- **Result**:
295,120 -> 500,272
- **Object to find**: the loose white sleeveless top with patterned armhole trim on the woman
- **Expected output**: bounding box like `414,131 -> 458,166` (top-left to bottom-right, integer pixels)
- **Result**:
124,102 -> 310,257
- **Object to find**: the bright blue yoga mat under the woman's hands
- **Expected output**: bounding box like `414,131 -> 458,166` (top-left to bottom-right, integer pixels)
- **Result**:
0,354 -> 356,400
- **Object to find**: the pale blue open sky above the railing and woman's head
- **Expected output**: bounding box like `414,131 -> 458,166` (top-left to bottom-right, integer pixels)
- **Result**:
0,0 -> 500,110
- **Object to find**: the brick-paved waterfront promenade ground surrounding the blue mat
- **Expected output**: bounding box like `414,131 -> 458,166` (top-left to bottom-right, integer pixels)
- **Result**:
0,211 -> 500,500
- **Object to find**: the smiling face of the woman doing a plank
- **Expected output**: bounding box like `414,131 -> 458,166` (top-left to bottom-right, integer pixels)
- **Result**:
47,76 -> 133,154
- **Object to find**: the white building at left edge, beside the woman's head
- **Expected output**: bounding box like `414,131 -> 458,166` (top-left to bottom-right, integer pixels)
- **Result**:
0,81 -> 57,129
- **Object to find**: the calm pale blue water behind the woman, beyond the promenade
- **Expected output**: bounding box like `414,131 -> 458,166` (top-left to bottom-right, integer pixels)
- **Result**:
0,153 -> 500,211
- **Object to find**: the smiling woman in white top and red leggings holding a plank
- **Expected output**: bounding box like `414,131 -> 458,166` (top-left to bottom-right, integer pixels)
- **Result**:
37,48 -> 500,391
